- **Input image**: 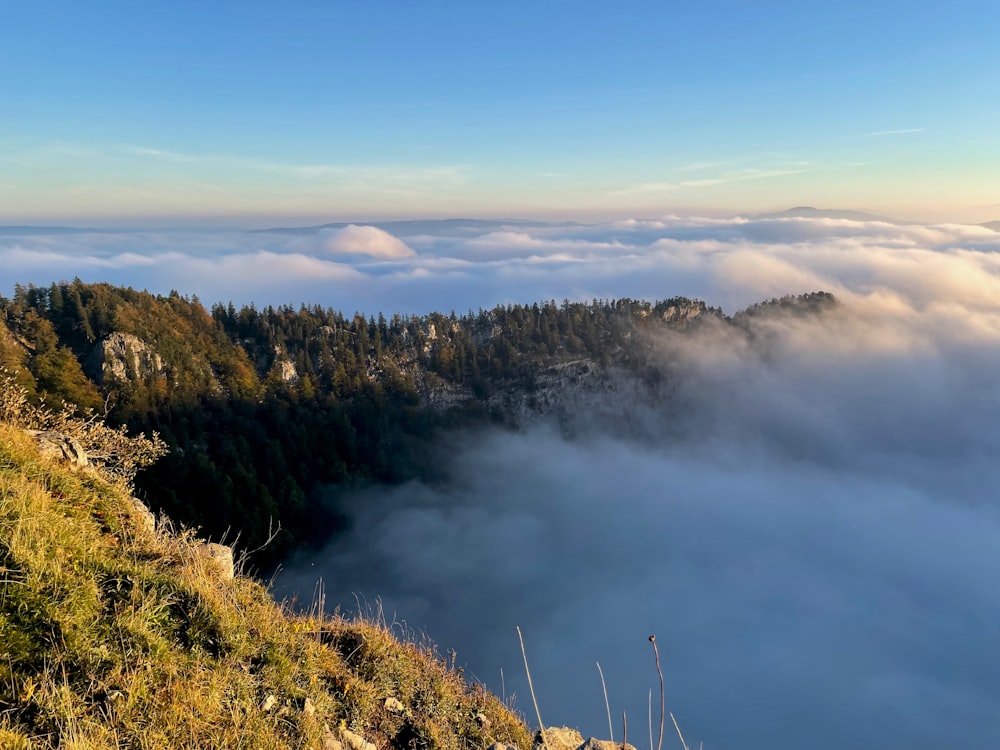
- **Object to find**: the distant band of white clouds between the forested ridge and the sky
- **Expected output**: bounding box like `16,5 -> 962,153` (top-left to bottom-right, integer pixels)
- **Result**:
0,215 -> 1000,314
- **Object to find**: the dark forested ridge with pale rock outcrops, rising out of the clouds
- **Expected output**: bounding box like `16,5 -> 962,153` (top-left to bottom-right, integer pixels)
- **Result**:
0,280 -> 834,566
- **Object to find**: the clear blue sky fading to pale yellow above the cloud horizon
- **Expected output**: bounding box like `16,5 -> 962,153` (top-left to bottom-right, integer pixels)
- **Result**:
0,0 -> 1000,225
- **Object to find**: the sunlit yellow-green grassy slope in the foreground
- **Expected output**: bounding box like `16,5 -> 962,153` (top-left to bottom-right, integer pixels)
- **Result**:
0,424 -> 530,750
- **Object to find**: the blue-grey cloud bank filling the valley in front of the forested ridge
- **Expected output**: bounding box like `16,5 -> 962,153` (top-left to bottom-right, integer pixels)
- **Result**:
279,294 -> 1000,750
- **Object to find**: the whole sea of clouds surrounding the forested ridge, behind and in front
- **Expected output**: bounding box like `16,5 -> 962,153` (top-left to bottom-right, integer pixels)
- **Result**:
0,216 -> 1000,750
